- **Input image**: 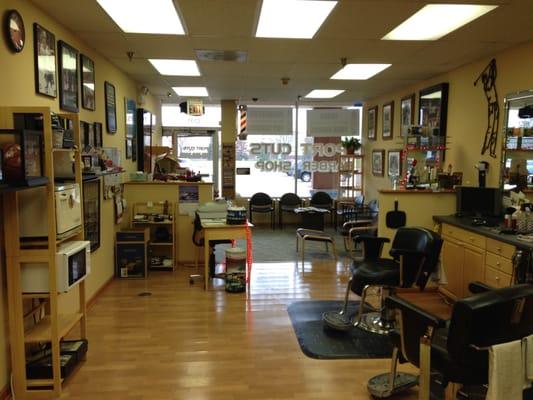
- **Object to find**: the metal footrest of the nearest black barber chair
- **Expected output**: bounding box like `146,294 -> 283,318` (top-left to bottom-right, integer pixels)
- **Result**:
367,348 -> 418,399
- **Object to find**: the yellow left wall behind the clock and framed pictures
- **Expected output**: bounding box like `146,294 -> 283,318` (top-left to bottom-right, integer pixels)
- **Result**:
0,0 -> 161,391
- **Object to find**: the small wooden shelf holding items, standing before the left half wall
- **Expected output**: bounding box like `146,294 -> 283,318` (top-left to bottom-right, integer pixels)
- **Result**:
131,201 -> 177,270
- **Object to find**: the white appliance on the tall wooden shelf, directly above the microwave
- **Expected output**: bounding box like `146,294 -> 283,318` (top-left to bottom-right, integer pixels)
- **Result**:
19,183 -> 81,238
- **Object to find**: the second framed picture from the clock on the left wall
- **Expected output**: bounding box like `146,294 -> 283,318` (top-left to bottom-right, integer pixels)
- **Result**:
58,40 -> 79,112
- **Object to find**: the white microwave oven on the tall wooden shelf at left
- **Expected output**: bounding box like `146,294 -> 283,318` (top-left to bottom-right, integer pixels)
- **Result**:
21,240 -> 91,293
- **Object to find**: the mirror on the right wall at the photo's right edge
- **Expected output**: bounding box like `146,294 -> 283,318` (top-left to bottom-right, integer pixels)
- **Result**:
500,90 -> 533,191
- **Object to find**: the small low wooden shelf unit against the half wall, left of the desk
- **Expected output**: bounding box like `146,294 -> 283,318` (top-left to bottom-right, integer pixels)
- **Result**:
131,201 -> 177,270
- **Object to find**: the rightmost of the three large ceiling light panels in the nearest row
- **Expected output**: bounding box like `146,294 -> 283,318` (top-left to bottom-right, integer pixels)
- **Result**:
383,4 -> 498,40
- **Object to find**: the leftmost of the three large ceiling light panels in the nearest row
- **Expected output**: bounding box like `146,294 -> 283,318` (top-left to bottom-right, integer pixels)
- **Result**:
96,0 -> 185,35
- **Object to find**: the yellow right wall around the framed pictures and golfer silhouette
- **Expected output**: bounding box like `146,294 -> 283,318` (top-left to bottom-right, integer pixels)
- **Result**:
363,42 -> 533,200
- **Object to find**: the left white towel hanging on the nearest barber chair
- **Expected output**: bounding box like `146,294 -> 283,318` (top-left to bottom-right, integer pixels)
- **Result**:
486,340 -> 524,400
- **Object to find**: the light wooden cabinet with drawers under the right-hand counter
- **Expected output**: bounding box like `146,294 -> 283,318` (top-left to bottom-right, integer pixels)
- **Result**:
441,224 -> 516,298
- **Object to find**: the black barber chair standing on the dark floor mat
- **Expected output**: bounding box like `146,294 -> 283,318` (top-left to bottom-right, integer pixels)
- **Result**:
322,227 -> 442,334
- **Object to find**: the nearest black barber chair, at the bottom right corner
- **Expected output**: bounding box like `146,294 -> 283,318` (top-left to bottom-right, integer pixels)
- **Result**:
368,283 -> 533,399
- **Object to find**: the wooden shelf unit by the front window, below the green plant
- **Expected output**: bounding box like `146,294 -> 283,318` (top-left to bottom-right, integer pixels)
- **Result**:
337,154 -> 364,201
